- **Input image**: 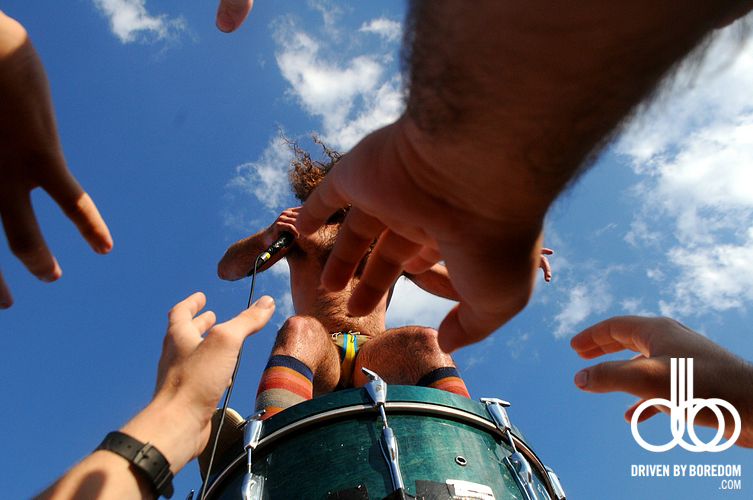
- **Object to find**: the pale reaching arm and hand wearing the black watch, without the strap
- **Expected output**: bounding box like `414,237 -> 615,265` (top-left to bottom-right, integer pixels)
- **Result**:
37,293 -> 274,500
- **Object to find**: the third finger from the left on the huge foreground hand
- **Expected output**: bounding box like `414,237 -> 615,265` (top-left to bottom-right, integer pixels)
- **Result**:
348,229 -> 421,316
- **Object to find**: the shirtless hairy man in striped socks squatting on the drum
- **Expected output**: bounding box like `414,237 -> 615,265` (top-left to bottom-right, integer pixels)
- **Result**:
218,147 -> 551,418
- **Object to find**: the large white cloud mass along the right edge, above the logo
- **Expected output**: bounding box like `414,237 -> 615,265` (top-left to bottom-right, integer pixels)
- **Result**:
617,21 -> 753,315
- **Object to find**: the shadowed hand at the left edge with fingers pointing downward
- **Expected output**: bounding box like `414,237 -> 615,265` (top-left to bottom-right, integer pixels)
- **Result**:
0,12 -> 113,309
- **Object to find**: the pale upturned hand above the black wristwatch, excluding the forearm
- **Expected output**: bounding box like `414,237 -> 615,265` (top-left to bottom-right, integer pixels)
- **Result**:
123,293 -> 275,472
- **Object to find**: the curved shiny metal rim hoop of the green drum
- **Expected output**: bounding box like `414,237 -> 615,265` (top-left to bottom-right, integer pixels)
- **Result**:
206,401 -> 555,498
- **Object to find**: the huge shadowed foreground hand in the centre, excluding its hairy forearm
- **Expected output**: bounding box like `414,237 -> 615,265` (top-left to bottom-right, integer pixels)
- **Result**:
296,117 -> 546,352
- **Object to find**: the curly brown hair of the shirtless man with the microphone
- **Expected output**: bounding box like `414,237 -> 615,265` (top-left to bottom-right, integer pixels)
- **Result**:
283,135 -> 350,224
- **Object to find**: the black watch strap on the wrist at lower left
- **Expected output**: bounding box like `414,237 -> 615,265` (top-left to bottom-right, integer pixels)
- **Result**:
95,431 -> 173,498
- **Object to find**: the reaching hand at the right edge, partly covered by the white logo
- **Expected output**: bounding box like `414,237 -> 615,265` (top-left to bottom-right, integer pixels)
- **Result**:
570,316 -> 753,448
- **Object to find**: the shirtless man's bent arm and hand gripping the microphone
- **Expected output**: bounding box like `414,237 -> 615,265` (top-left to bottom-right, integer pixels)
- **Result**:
217,207 -> 301,281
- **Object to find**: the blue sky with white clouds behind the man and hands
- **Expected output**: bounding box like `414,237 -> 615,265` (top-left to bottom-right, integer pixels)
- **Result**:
0,0 -> 753,499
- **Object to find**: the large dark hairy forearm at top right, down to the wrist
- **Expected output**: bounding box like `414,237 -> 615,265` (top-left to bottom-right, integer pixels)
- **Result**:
406,0 -> 751,211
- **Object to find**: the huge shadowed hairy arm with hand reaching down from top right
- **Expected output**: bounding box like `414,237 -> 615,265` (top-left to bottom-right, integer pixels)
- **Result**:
297,0 -> 751,350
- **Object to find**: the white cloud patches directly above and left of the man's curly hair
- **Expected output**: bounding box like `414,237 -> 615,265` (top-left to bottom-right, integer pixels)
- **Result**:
226,8 -> 403,221
